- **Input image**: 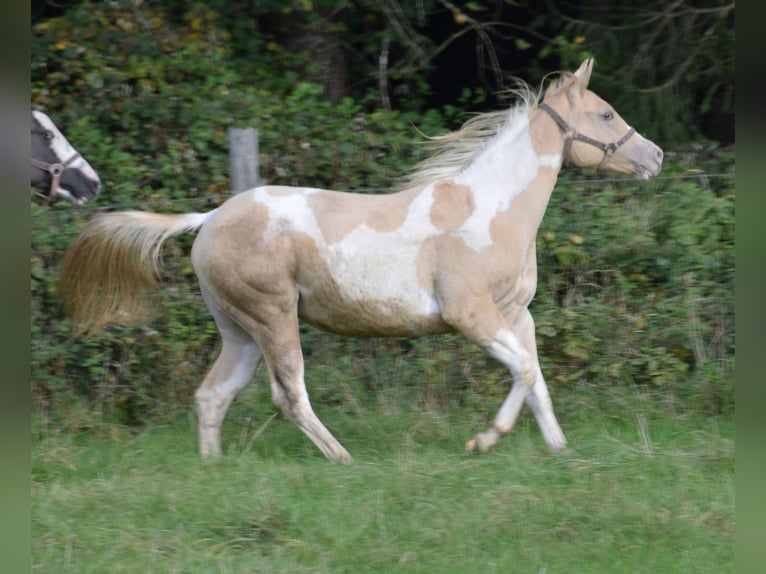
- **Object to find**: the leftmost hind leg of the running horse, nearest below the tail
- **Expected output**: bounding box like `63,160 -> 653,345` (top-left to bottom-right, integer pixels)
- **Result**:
195,293 -> 261,456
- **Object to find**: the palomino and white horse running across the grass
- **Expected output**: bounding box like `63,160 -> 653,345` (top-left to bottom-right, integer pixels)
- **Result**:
60,60 -> 663,462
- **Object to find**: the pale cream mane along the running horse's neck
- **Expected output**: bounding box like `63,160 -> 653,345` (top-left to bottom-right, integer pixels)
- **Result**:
400,72 -> 572,189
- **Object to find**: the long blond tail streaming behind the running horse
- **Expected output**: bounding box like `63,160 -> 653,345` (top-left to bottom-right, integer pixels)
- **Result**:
59,211 -> 209,333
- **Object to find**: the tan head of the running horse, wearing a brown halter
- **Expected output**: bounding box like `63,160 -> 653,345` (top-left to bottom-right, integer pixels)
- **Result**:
540,59 -> 663,179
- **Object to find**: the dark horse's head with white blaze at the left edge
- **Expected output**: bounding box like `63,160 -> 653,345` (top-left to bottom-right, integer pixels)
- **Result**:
32,110 -> 101,205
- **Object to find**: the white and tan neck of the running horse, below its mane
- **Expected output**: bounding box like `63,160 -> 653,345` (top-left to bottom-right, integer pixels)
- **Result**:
457,111 -> 563,234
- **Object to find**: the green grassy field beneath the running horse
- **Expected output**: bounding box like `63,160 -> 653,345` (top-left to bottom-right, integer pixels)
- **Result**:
32,389 -> 735,574
